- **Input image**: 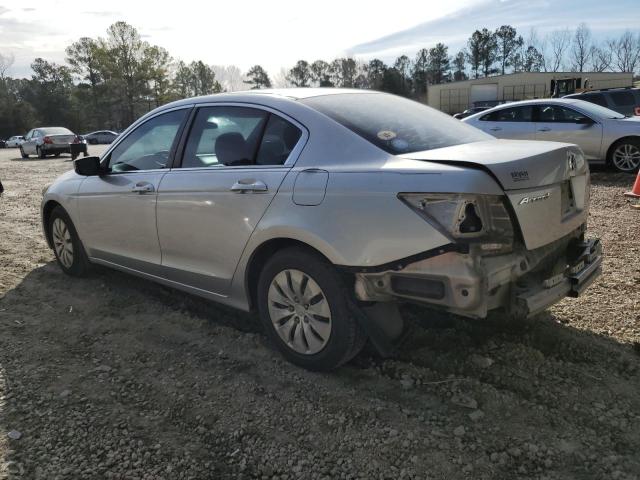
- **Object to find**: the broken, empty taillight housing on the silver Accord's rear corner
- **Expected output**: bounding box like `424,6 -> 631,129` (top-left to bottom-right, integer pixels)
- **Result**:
398,193 -> 514,253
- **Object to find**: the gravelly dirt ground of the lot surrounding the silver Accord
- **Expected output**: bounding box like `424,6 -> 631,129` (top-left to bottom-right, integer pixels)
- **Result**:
0,147 -> 640,480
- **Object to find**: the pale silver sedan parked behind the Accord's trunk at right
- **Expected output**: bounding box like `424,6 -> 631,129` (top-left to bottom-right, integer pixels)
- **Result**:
462,98 -> 640,172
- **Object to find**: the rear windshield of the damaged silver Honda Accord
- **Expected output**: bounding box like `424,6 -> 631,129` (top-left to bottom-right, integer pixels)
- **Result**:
300,93 -> 493,155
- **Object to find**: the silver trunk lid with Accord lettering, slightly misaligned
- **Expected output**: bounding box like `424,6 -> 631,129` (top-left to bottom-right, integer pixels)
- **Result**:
402,140 -> 589,250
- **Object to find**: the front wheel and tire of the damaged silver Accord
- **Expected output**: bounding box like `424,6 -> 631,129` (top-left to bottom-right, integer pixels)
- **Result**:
48,207 -> 90,277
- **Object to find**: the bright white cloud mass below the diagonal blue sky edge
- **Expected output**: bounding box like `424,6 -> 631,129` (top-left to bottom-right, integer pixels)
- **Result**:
0,0 -> 474,75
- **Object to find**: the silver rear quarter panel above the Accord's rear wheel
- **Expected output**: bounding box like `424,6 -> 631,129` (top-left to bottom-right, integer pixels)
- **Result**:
231,162 -> 503,303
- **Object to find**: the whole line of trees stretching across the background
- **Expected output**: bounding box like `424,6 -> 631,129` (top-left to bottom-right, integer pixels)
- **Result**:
0,22 -> 640,137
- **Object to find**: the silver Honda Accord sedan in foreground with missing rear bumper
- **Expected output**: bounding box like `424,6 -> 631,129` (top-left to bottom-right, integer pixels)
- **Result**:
42,88 -> 601,370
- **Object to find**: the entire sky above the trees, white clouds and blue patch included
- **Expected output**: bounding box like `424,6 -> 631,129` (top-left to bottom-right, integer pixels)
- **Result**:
0,0 -> 640,77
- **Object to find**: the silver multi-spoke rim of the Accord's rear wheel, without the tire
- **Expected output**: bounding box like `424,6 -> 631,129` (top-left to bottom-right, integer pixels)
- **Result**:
268,269 -> 331,355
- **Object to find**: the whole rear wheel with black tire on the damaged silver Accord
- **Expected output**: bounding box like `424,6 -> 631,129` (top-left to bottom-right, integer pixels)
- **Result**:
258,247 -> 366,371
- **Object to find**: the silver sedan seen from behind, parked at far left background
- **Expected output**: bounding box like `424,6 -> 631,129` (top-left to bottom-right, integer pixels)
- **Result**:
20,127 -> 87,159
